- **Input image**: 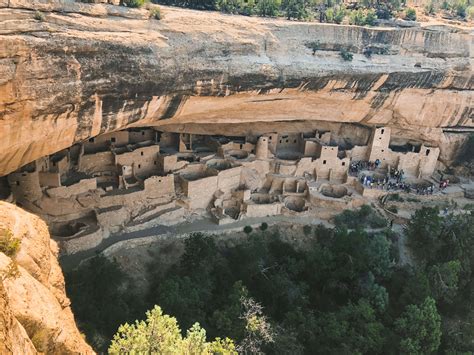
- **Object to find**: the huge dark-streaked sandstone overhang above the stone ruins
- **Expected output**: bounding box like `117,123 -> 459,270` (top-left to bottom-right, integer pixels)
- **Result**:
0,0 -> 474,176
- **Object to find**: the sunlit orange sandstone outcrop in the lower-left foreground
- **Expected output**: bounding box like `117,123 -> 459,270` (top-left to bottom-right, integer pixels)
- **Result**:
0,201 -> 93,355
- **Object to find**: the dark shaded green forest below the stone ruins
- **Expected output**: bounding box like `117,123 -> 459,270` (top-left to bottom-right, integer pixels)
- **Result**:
66,208 -> 474,354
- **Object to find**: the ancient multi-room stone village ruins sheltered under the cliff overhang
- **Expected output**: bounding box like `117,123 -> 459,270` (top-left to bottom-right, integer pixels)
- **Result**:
2,126 -> 466,254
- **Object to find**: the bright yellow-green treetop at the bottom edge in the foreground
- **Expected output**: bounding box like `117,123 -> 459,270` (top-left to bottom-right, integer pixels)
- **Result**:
109,306 -> 237,355
